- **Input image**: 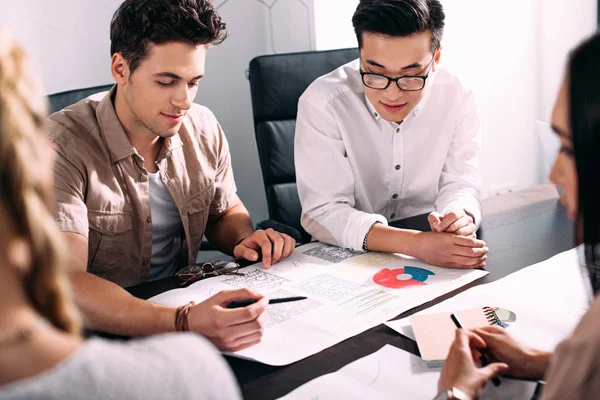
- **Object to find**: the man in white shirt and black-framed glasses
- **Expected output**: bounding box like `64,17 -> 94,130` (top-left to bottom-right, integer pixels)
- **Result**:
295,0 -> 488,268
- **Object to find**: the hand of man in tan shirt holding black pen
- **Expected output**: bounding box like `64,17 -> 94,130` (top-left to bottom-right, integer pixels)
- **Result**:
188,289 -> 269,351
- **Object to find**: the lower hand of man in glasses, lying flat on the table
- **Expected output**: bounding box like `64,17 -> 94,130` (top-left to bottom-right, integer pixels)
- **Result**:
411,232 -> 488,268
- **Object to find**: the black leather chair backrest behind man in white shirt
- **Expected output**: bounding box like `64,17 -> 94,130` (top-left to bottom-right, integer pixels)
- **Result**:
250,48 -> 358,241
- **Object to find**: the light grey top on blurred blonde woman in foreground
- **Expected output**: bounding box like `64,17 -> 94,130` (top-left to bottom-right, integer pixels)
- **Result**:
0,333 -> 241,400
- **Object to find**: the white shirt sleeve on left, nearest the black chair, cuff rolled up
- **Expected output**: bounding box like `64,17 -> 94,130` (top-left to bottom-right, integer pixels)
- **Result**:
294,98 -> 387,251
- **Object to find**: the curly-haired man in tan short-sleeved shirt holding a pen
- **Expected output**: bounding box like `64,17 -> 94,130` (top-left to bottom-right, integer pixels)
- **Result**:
44,0 -> 295,351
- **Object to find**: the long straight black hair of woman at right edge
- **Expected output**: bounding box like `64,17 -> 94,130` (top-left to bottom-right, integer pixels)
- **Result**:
568,33 -> 600,292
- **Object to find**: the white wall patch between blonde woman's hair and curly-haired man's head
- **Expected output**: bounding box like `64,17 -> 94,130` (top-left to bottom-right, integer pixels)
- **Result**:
0,0 -> 121,93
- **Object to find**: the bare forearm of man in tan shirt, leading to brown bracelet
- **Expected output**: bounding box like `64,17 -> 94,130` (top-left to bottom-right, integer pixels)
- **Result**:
69,271 -> 175,336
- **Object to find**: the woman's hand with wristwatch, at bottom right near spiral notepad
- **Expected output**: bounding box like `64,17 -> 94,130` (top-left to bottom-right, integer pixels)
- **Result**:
438,329 -> 508,399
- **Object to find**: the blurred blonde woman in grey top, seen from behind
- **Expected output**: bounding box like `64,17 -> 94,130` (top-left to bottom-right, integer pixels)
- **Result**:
0,28 -> 240,399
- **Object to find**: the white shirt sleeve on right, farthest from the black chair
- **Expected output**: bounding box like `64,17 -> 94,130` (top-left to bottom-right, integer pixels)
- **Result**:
436,91 -> 482,226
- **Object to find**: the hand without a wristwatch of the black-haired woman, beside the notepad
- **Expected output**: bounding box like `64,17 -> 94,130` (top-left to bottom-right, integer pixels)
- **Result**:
472,326 -> 550,380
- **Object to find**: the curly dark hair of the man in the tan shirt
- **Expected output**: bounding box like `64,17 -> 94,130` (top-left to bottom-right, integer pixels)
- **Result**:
110,0 -> 227,72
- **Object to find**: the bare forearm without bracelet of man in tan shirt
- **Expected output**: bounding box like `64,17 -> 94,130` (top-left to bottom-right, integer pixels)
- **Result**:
204,202 -> 254,254
